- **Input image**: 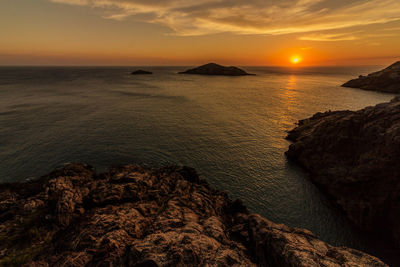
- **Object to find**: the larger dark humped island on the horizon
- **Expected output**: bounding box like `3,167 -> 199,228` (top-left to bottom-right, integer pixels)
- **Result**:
179,63 -> 255,76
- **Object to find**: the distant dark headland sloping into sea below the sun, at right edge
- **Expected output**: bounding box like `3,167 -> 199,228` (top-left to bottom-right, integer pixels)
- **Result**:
342,61 -> 400,93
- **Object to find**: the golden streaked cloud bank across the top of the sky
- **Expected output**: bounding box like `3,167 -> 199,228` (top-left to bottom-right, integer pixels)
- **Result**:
49,0 -> 400,35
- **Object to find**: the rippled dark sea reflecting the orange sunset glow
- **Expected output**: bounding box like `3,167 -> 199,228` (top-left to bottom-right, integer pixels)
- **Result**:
0,66 -> 393,253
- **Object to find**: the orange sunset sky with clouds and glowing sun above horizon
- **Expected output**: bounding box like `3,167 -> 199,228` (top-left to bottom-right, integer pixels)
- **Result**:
0,0 -> 400,66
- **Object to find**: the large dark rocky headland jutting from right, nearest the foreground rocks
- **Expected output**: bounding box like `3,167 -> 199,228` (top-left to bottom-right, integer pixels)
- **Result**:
286,97 -> 400,251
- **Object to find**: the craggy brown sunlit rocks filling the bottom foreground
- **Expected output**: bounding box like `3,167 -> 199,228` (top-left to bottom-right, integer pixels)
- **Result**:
0,164 -> 386,266
